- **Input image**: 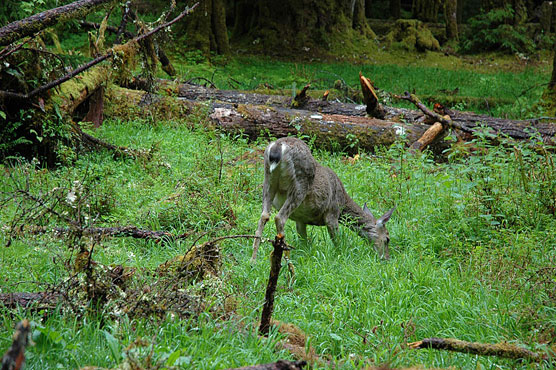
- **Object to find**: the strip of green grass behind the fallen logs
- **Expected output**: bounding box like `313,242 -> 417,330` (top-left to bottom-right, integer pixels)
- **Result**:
170,52 -> 550,118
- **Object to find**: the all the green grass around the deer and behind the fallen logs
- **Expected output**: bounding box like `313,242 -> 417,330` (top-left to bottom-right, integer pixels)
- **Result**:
0,53 -> 556,369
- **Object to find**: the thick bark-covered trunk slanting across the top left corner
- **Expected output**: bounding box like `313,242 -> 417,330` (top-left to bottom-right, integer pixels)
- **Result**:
0,0 -> 114,46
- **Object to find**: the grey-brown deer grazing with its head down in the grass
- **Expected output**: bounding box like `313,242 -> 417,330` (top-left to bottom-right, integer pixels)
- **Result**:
251,137 -> 396,261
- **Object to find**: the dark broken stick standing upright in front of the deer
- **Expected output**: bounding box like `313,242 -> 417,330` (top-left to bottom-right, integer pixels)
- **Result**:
259,235 -> 286,335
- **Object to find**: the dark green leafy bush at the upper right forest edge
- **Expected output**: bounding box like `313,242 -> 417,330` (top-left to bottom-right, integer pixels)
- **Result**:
461,5 -> 536,54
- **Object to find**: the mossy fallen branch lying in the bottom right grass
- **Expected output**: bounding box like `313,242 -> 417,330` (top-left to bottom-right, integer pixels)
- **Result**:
408,338 -> 554,362
